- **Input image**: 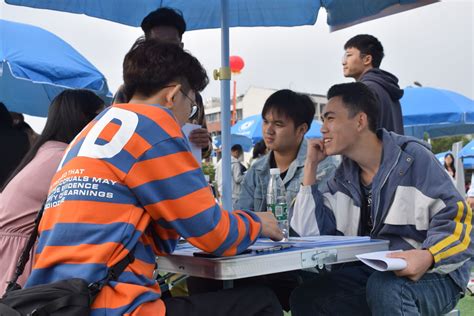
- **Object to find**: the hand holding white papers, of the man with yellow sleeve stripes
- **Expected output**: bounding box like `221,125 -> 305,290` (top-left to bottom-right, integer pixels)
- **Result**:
387,249 -> 434,281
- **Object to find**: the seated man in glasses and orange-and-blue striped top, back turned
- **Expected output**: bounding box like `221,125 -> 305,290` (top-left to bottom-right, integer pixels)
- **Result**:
27,40 -> 282,316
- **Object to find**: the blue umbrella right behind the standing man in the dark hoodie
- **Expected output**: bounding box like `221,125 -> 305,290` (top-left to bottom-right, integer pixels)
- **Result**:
400,87 -> 474,138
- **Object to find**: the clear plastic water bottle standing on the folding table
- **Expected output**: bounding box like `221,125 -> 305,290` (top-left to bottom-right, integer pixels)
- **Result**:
267,168 -> 290,240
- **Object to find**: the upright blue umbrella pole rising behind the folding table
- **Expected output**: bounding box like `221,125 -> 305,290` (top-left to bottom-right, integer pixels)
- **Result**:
219,0 -> 232,211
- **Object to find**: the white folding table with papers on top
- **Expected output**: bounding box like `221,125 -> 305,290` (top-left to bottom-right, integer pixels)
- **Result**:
157,236 -> 389,280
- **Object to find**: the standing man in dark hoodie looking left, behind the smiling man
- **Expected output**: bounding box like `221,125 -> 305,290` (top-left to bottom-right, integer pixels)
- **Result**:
342,34 -> 404,135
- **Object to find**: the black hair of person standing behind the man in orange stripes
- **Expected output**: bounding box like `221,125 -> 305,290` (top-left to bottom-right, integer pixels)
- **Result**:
141,7 -> 186,38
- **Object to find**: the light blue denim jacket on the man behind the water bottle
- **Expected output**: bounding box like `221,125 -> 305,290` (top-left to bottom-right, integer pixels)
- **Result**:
235,139 -> 339,217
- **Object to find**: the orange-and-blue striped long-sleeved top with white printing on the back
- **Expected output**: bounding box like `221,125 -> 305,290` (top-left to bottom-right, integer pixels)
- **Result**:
26,104 -> 261,315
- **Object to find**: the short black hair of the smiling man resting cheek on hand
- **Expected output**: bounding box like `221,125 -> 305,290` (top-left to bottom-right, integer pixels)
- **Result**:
327,82 -> 379,133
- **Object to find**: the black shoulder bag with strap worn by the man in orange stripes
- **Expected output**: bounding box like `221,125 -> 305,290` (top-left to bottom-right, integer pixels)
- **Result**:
0,205 -> 135,316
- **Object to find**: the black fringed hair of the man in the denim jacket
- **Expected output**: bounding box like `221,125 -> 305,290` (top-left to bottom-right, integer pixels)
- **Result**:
262,89 -> 316,130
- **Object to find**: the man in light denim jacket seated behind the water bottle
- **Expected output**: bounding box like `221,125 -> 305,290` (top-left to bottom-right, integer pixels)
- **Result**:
235,90 -> 338,217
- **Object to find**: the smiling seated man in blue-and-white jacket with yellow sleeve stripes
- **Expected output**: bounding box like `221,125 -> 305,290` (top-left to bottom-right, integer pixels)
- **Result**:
291,83 -> 473,316
